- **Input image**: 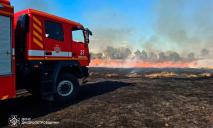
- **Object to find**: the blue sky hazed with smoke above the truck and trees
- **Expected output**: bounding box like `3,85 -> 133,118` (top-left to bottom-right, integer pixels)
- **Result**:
11,0 -> 213,54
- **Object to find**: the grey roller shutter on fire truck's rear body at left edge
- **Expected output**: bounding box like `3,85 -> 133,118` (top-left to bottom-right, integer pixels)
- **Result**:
0,16 -> 12,75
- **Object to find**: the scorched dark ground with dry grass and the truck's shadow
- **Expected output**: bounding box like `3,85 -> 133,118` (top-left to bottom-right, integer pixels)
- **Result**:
0,68 -> 213,128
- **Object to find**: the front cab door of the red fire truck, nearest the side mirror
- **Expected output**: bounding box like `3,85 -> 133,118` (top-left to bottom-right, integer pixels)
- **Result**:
71,29 -> 89,60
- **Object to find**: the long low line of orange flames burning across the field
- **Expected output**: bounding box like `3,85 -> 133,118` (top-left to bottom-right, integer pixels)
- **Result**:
90,59 -> 213,69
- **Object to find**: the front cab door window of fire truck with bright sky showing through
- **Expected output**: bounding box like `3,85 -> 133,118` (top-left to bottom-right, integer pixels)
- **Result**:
72,30 -> 85,43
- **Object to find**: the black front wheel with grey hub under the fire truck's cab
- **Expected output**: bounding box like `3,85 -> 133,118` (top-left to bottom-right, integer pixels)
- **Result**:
55,73 -> 79,104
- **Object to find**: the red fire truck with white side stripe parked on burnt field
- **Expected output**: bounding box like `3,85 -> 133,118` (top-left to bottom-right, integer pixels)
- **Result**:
0,0 -> 92,102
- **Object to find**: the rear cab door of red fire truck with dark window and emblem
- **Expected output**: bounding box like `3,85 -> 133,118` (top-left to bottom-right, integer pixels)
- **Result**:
45,20 -> 71,60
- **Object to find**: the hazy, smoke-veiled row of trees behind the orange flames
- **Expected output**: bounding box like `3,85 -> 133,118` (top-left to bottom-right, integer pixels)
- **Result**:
91,46 -> 197,62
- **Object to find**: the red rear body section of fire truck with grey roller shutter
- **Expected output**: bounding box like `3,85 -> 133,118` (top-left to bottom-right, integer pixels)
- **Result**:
0,0 -> 16,100
